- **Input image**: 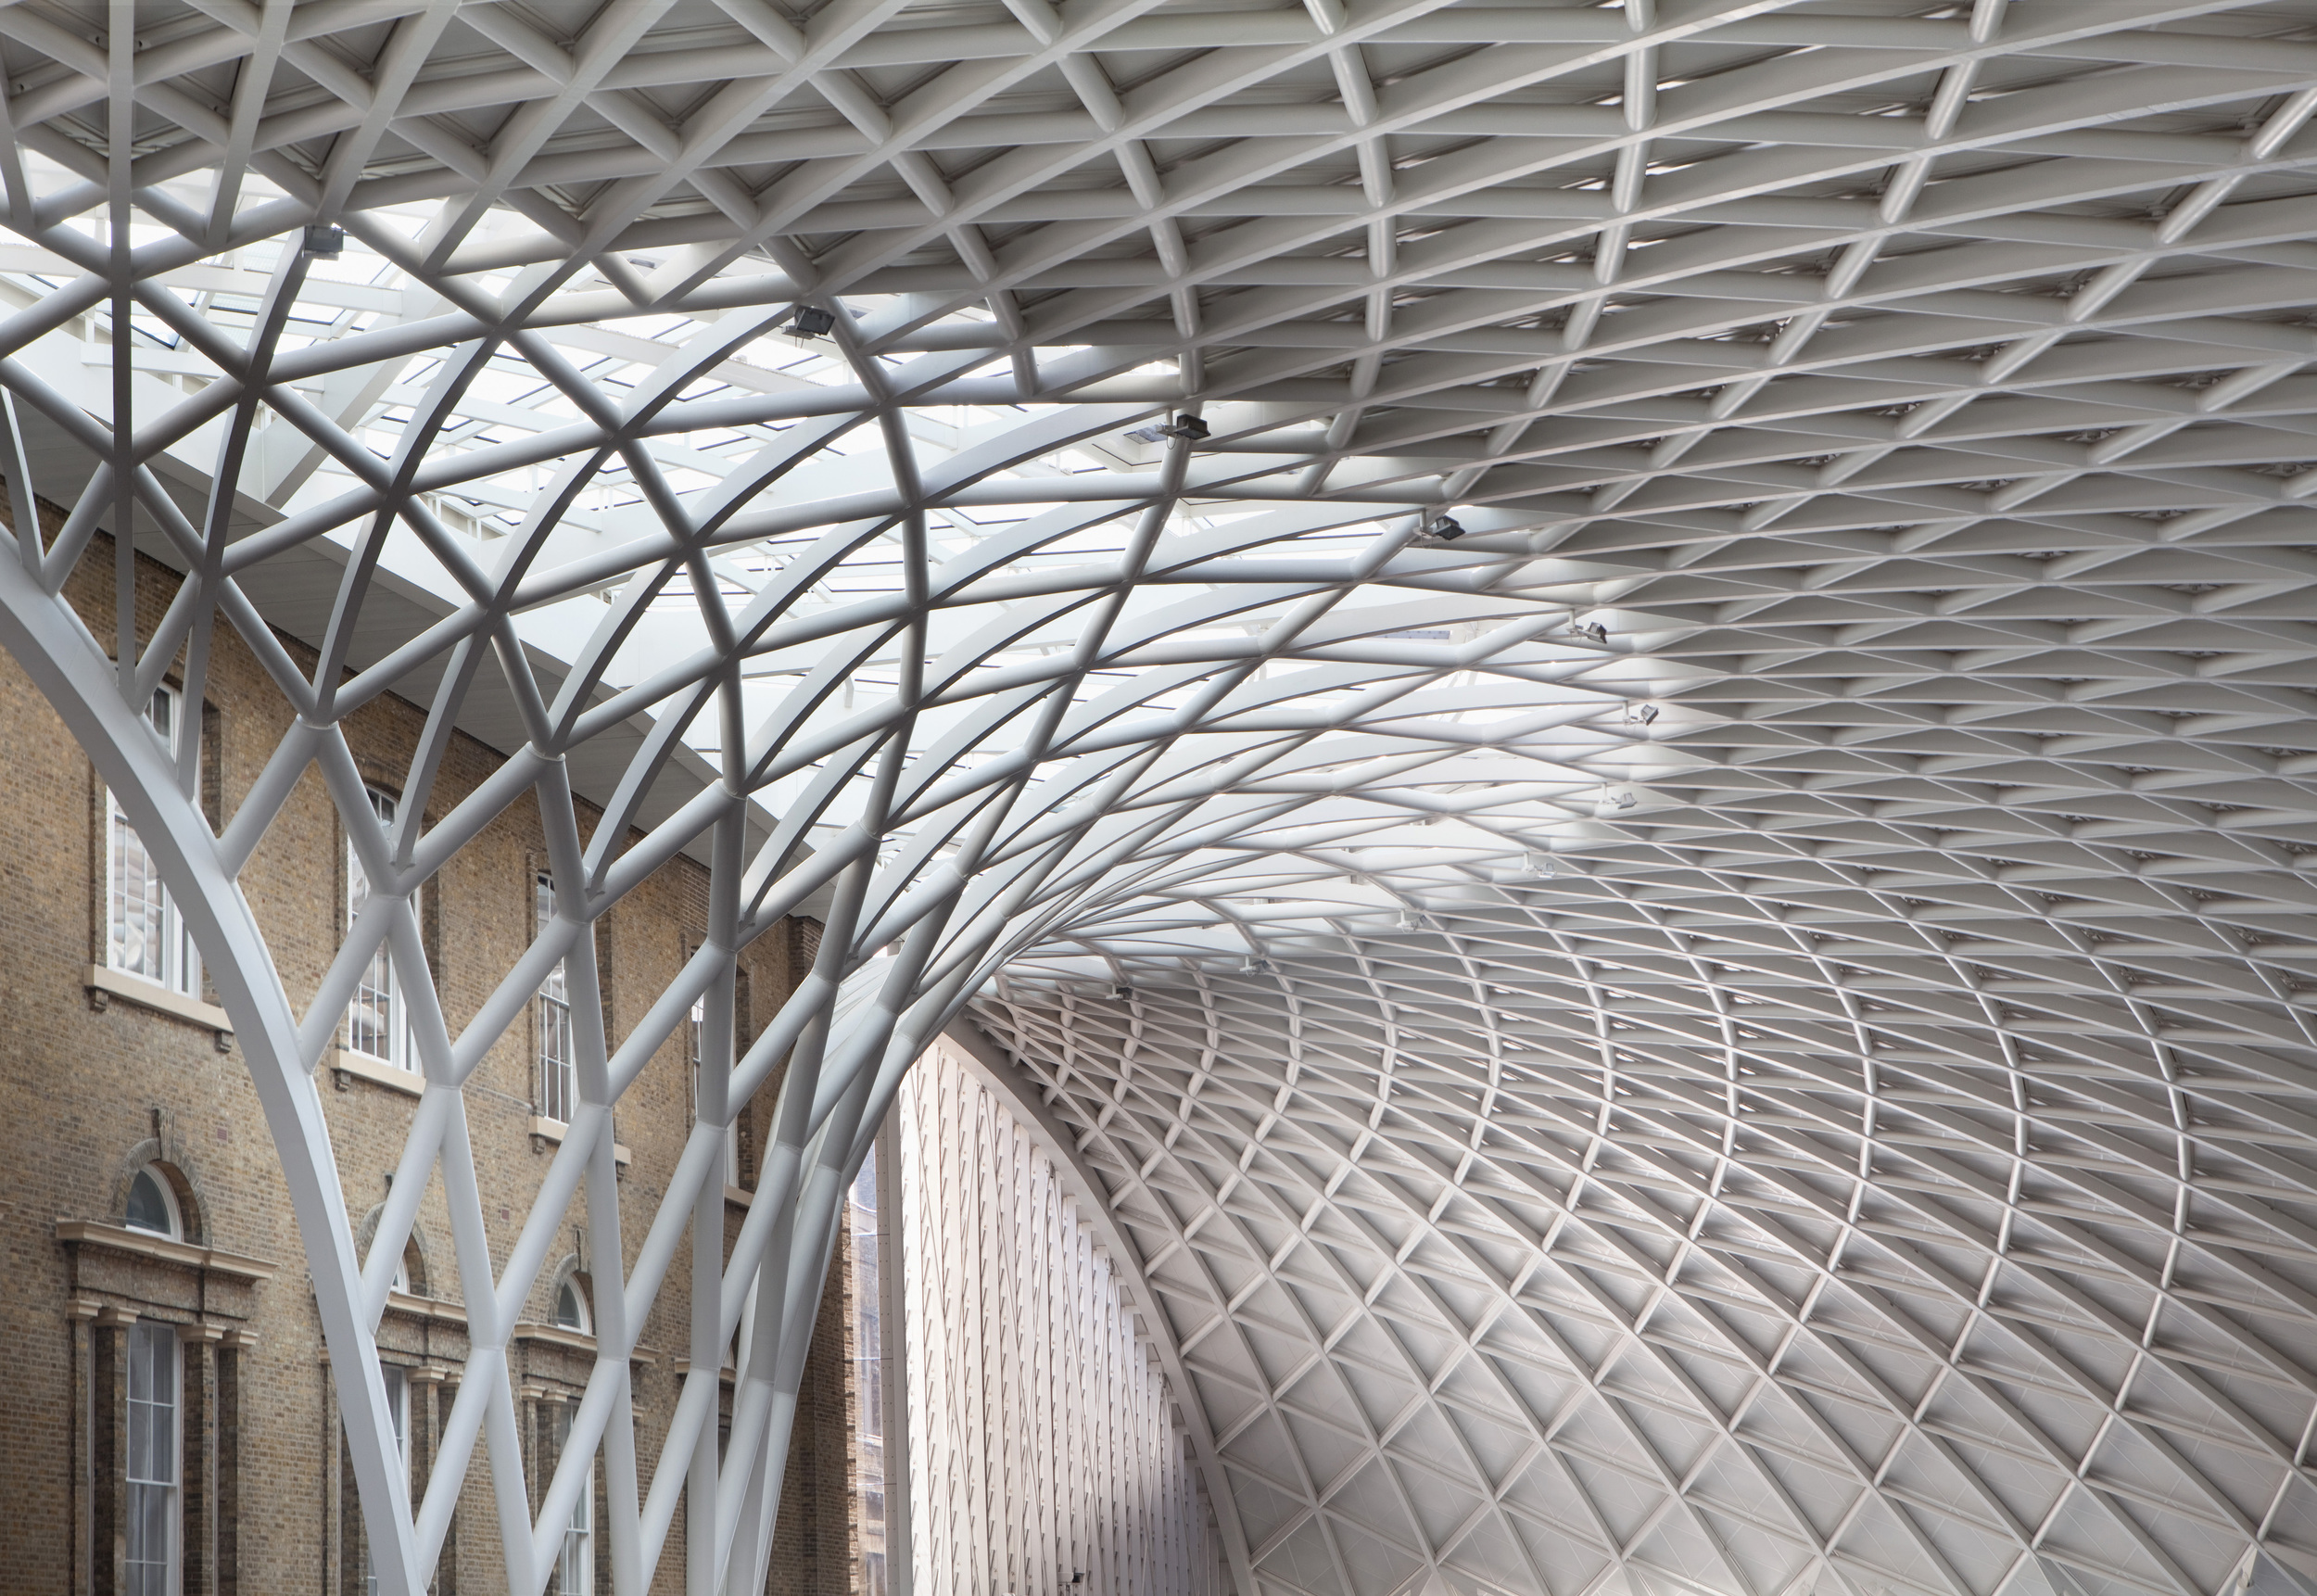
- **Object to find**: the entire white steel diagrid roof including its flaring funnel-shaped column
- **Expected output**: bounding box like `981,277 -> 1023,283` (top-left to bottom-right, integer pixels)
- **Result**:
0,0 -> 2317,1596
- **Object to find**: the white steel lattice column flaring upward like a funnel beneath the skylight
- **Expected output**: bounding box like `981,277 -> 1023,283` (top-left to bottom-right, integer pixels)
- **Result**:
0,171 -> 1412,1594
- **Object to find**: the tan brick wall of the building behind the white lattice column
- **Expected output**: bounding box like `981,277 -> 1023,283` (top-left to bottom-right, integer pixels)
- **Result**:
0,528 -> 867,1596
